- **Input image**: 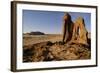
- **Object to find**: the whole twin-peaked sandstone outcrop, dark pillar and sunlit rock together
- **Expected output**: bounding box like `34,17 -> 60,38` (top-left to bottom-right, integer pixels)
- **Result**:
63,13 -> 88,45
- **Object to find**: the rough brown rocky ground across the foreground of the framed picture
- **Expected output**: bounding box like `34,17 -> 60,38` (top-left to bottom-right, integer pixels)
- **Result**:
23,41 -> 91,62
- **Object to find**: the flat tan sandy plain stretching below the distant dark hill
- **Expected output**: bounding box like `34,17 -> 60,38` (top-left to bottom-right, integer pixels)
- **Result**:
23,34 -> 62,46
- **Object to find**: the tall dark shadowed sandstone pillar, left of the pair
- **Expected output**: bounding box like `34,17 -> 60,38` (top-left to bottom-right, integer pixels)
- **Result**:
63,13 -> 73,42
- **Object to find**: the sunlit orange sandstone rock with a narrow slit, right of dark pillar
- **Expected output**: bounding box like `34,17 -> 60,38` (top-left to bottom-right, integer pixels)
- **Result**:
72,17 -> 88,45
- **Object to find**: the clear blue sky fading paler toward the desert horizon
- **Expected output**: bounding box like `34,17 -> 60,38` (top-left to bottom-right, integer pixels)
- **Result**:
22,10 -> 91,34
